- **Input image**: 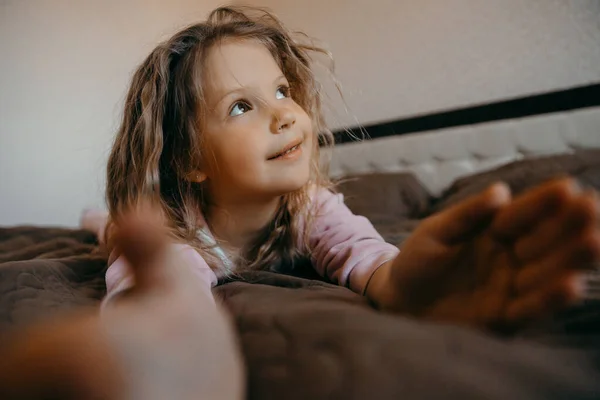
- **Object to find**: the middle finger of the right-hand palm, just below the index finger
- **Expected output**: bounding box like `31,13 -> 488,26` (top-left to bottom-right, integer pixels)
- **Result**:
514,192 -> 600,264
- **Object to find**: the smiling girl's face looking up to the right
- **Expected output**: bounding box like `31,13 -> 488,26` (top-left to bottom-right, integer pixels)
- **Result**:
202,40 -> 313,202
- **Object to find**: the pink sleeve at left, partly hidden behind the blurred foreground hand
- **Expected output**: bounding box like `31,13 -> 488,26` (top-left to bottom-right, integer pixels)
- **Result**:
101,244 -> 217,307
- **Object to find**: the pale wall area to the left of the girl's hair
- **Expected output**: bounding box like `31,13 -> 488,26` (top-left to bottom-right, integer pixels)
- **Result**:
0,0 -> 224,225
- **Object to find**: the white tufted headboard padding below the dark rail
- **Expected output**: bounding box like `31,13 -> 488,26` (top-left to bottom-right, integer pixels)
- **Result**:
330,106 -> 600,195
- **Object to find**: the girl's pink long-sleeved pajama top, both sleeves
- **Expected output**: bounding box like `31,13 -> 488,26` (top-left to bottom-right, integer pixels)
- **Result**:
104,189 -> 399,303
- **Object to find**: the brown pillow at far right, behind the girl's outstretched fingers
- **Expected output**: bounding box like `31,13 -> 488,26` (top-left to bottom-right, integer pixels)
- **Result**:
431,149 -> 600,213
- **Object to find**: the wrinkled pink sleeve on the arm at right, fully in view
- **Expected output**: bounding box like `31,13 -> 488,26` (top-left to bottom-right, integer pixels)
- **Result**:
309,189 -> 399,293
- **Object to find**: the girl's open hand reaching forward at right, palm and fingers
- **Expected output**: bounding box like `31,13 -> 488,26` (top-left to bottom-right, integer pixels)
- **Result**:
367,180 -> 600,328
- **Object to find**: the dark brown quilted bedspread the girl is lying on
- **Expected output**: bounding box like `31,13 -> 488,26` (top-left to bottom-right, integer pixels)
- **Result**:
0,151 -> 600,399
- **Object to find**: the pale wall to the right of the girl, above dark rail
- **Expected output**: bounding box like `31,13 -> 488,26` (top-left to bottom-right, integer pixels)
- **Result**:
246,0 -> 600,126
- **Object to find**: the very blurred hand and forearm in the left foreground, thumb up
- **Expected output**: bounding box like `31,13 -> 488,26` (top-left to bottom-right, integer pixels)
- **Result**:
0,206 -> 244,400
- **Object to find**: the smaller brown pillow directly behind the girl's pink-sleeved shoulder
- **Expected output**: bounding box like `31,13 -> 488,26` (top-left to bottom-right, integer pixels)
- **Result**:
337,173 -> 431,225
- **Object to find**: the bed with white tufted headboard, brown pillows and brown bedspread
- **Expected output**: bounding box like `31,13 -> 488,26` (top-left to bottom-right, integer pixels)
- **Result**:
0,101 -> 600,399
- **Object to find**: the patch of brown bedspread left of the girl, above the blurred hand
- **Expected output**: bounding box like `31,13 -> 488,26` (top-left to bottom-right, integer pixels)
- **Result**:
0,227 -> 106,331
